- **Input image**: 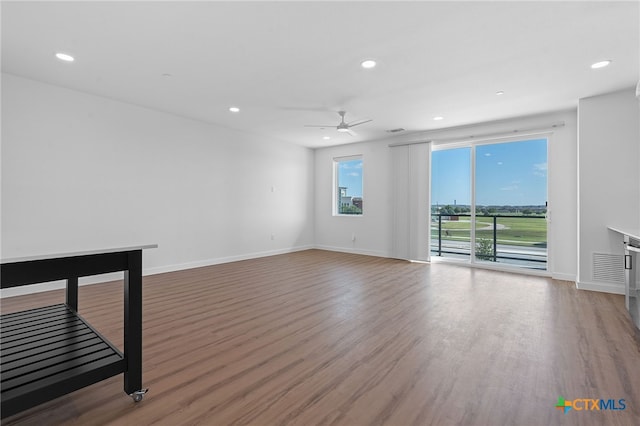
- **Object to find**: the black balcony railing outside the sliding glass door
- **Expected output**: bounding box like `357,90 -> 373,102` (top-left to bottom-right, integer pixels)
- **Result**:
431,213 -> 547,269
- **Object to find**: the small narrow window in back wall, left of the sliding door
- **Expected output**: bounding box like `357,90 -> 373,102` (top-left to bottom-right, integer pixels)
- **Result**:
333,155 -> 363,215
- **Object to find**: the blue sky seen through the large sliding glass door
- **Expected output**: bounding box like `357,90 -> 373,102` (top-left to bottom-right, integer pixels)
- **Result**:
431,139 -> 547,206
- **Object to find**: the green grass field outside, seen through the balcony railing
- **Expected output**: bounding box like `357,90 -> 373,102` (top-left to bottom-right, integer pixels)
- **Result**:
431,216 -> 547,247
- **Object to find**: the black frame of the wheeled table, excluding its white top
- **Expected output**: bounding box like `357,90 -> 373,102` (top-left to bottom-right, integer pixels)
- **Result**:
0,249 -> 144,418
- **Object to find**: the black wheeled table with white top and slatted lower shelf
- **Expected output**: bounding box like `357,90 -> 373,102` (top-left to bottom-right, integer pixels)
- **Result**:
0,244 -> 157,418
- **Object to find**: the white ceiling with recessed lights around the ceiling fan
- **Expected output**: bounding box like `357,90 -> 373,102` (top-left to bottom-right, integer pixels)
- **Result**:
1,1 -> 640,147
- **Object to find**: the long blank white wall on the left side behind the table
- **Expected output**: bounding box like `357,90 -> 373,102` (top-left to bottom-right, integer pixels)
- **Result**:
2,74 -> 314,294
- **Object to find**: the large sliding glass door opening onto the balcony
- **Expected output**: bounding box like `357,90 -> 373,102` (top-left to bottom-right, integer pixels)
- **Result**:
431,138 -> 547,269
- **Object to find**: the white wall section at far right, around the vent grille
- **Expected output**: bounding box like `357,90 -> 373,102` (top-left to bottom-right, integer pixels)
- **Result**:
578,88 -> 640,293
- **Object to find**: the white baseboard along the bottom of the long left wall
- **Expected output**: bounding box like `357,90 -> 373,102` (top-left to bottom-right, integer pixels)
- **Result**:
0,245 -> 314,303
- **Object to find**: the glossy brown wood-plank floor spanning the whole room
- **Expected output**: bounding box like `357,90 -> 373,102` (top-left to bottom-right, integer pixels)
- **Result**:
2,250 -> 640,425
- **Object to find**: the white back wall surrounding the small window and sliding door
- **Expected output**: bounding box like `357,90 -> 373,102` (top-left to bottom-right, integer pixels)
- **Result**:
315,111 -> 577,281
